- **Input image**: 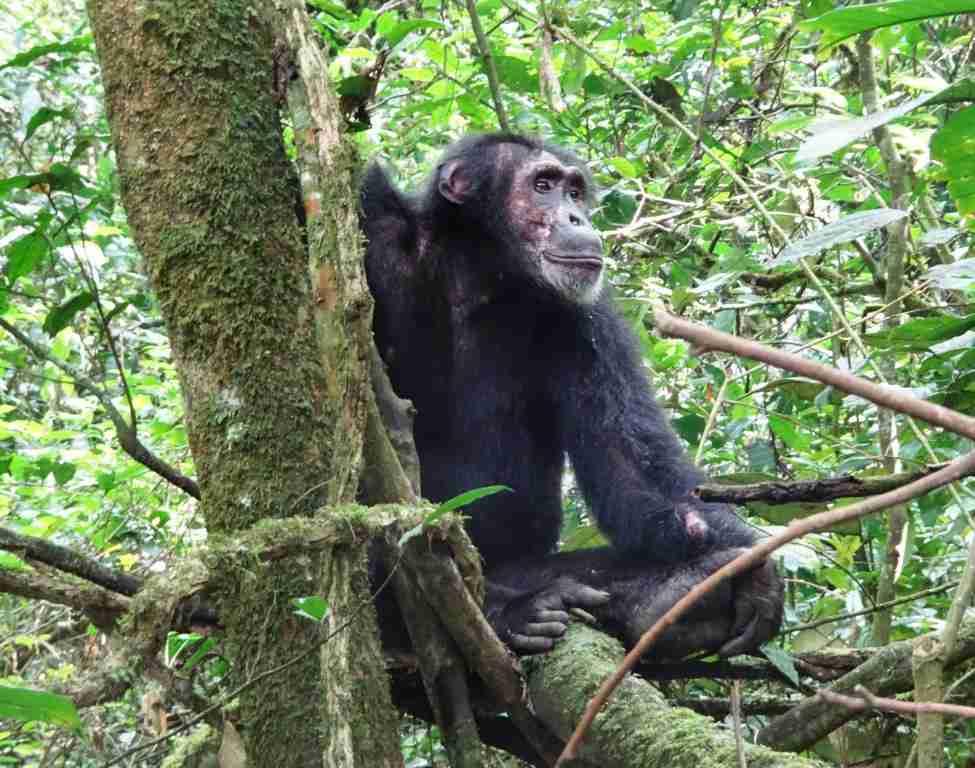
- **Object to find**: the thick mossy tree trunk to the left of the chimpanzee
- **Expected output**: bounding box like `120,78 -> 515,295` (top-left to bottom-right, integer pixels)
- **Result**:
88,0 -> 402,768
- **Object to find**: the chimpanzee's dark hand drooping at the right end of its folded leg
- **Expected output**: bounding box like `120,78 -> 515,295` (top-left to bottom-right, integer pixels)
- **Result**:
718,550 -> 784,656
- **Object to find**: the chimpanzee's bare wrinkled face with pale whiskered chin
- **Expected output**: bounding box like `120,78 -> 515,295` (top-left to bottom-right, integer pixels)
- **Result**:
506,152 -> 603,306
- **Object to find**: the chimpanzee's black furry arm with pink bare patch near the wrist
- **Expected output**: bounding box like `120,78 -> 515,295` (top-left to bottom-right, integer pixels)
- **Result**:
559,299 -> 756,562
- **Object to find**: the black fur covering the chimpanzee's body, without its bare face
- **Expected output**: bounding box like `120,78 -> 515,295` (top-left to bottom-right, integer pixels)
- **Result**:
362,134 -> 781,651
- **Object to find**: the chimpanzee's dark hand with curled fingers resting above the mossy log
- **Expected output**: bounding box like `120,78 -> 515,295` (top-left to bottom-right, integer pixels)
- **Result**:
496,577 -> 610,654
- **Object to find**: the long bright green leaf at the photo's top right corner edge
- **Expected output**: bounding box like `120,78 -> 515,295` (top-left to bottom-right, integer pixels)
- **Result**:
799,0 -> 975,46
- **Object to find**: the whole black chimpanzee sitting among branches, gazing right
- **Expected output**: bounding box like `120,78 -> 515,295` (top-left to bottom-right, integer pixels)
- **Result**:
362,134 -> 782,657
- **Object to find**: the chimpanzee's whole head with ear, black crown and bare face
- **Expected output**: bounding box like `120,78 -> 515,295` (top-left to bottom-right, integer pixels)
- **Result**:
428,134 -> 603,305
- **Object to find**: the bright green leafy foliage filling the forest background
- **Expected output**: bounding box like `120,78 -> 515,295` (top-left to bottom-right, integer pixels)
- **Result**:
0,0 -> 975,765
